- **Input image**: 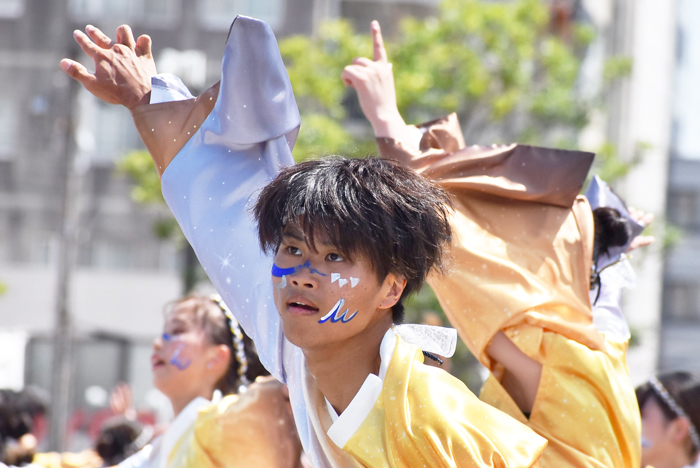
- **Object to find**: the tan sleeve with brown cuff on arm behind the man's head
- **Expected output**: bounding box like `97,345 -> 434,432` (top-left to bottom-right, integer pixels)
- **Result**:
377,114 -> 604,367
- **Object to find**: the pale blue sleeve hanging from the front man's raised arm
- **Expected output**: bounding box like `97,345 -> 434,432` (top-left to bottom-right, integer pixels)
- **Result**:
154,17 -> 299,379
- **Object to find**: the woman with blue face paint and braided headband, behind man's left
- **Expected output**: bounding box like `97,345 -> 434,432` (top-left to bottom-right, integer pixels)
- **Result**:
113,295 -> 301,468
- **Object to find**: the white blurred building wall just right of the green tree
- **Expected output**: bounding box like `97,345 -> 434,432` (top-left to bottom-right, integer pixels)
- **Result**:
570,0 -> 680,384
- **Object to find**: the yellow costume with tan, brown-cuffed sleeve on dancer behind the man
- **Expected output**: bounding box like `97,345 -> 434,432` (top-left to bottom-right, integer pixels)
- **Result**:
378,115 -> 641,468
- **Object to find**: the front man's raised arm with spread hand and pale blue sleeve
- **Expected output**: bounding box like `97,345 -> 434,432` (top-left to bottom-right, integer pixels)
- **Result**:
61,16 -> 299,380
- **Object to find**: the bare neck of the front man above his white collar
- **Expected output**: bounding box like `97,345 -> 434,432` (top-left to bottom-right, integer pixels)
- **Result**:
304,314 -> 392,414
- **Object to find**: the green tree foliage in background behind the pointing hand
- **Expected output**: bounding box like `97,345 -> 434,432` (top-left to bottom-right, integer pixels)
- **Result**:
280,0 -> 616,160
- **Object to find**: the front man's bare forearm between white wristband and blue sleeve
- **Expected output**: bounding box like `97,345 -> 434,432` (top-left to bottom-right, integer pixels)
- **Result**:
131,83 -> 220,175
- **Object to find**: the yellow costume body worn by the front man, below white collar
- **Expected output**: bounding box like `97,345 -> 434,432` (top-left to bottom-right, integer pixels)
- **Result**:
306,330 -> 547,468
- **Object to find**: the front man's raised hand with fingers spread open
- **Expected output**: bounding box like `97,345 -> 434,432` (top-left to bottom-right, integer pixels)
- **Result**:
61,25 -> 157,109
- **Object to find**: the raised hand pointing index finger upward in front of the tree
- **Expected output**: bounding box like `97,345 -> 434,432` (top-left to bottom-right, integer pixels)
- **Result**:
341,21 -> 406,139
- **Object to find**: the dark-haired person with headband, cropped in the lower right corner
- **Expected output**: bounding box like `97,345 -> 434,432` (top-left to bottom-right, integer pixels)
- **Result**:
637,372 -> 700,468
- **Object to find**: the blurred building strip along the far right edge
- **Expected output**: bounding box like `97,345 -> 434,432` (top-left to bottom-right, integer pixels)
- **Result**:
660,0 -> 700,372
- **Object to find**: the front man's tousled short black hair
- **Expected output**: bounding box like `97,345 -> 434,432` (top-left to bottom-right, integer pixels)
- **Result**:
253,156 -> 451,323
